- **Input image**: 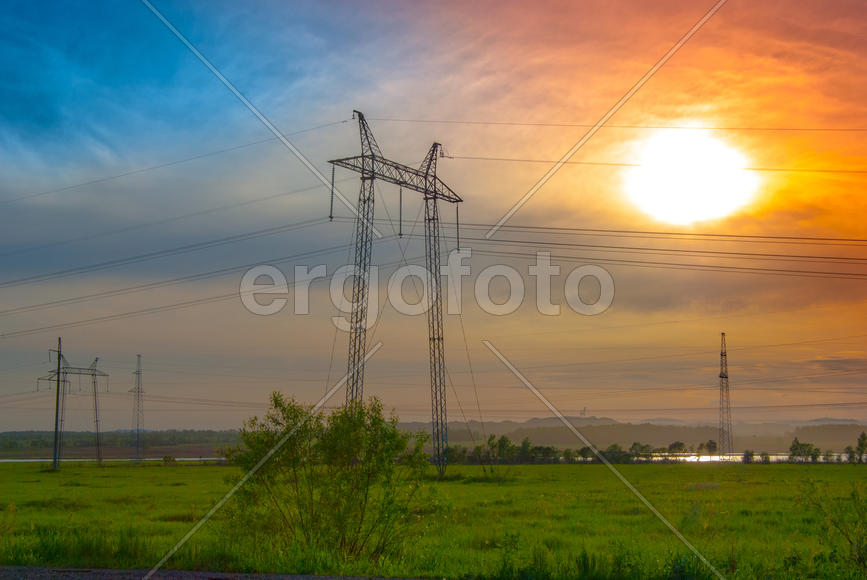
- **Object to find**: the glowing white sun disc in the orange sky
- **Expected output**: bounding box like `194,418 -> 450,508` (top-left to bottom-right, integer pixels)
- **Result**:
624,129 -> 759,225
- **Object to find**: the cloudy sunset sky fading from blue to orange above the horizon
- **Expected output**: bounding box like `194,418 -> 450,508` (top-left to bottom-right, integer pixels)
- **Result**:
0,0 -> 867,431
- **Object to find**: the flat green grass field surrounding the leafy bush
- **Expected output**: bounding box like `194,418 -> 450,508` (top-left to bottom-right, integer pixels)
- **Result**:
0,464 -> 867,578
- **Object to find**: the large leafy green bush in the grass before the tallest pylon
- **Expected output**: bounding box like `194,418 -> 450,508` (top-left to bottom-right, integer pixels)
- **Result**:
227,392 -> 429,560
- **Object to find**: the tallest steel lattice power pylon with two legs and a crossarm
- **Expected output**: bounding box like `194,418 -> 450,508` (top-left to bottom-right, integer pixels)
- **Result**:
329,111 -> 463,476
